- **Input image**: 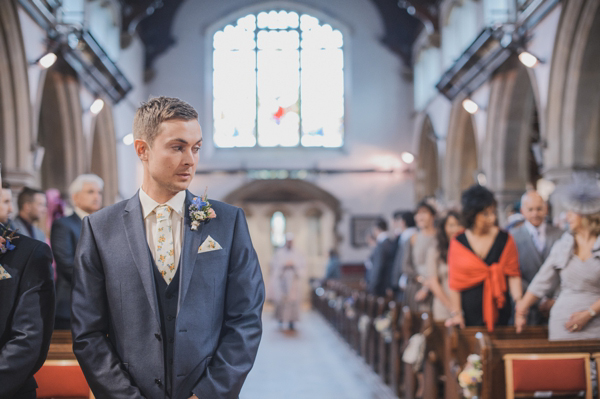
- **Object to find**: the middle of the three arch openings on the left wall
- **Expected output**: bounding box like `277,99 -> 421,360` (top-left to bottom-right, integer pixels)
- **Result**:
38,65 -> 87,193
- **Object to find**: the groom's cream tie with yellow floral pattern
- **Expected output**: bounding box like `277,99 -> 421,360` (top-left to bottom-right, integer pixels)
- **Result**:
154,205 -> 177,284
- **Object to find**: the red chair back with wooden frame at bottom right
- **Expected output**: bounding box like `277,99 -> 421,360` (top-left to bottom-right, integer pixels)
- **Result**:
504,353 -> 592,399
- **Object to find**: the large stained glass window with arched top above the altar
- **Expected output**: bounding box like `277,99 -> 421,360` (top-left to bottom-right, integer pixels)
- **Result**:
213,11 -> 344,148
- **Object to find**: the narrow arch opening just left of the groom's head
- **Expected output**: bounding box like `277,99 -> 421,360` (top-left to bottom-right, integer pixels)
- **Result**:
90,101 -> 119,205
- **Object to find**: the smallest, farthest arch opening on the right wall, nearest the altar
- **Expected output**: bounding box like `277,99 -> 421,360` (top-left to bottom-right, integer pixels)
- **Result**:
415,116 -> 439,201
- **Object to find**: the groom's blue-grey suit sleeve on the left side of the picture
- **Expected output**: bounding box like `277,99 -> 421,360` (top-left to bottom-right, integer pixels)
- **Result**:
71,217 -> 143,399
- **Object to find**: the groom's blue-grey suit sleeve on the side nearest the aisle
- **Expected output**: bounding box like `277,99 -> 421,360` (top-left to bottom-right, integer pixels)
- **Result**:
192,209 -> 265,399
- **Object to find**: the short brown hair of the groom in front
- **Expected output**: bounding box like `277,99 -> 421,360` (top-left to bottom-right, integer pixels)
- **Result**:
133,97 -> 198,146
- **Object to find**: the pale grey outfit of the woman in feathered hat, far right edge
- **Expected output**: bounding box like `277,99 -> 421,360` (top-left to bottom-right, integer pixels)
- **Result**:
528,233 -> 600,341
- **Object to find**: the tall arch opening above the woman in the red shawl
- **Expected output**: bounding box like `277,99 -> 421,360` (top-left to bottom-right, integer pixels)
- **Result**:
481,58 -> 543,209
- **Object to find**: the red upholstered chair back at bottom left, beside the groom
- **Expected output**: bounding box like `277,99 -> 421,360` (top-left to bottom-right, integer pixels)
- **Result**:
35,360 -> 94,399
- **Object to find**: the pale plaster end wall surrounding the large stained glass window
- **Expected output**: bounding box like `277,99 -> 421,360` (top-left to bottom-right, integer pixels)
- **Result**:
145,0 -> 414,262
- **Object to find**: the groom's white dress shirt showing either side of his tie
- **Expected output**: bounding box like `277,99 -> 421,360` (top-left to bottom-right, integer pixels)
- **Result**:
140,188 -> 185,267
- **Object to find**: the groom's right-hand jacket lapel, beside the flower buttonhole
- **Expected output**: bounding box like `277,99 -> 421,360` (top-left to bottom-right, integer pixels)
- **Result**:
179,191 -> 206,306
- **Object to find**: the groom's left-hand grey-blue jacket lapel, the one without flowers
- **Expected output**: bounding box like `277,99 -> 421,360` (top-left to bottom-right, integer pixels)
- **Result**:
123,193 -> 160,323
